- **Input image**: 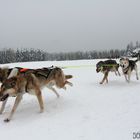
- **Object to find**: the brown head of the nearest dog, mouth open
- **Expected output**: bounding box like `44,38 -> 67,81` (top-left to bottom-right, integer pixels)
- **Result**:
0,77 -> 17,101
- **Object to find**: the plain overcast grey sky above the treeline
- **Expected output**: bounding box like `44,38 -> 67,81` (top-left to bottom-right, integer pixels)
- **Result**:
0,0 -> 140,52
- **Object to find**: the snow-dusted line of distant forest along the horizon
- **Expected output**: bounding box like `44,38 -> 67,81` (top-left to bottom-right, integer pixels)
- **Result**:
0,42 -> 140,64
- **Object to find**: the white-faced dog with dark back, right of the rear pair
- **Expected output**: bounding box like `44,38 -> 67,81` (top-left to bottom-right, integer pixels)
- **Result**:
120,58 -> 139,83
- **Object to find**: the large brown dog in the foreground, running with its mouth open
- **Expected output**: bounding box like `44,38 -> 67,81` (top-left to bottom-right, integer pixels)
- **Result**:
0,67 -> 72,122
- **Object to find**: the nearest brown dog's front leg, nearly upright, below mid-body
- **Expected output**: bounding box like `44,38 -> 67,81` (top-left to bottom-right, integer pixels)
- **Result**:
35,89 -> 44,113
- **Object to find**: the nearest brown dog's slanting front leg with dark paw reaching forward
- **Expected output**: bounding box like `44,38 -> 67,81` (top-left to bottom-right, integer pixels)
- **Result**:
4,94 -> 22,122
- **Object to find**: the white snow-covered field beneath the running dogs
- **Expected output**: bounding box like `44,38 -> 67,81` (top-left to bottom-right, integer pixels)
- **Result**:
0,60 -> 140,140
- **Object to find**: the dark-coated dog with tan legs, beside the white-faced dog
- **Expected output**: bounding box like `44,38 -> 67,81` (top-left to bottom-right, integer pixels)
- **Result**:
96,60 -> 120,84
